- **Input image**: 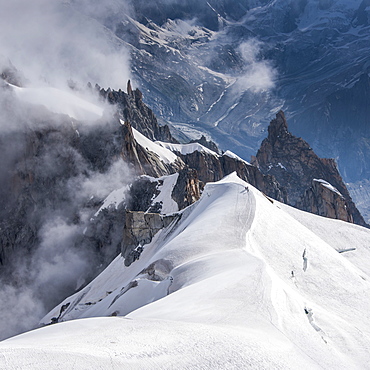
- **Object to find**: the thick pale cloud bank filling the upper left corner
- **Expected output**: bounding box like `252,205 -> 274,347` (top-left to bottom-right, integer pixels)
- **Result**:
0,0 -> 130,89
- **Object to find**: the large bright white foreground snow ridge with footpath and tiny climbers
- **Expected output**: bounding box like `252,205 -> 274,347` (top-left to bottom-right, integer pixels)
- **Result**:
0,174 -> 370,369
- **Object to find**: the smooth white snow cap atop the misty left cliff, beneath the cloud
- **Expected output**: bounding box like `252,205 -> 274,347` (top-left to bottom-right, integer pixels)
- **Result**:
8,84 -> 104,121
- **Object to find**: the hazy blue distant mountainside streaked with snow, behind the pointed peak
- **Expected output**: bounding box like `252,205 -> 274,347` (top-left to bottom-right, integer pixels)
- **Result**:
107,0 -> 370,182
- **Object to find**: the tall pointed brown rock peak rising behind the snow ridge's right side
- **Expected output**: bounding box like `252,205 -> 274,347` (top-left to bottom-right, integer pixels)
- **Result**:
254,111 -> 366,226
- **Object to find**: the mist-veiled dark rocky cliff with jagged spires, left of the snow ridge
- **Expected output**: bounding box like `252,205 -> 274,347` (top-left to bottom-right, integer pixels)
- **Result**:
0,79 -> 194,292
